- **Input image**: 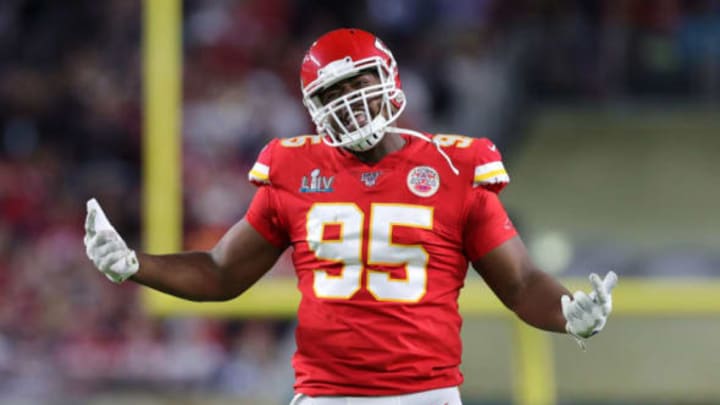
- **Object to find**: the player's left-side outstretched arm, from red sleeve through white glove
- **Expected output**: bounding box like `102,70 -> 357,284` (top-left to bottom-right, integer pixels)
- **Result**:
85,199 -> 282,301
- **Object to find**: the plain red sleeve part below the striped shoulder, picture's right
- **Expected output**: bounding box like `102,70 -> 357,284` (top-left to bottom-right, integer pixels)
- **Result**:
463,189 -> 517,262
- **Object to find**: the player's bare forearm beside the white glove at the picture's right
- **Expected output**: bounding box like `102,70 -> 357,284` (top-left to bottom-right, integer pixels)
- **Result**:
511,270 -> 570,332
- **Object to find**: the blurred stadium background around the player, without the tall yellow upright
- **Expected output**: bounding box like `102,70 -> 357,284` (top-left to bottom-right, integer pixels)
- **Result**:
0,0 -> 720,404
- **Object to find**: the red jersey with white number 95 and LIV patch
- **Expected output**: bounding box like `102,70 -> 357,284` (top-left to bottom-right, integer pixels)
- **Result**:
246,135 -> 516,396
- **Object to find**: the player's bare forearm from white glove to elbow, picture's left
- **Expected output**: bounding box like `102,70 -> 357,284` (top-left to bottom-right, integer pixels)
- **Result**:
131,252 -> 238,301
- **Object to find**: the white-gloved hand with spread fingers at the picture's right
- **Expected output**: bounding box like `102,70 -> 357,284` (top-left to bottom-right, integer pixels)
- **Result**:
560,271 -> 617,340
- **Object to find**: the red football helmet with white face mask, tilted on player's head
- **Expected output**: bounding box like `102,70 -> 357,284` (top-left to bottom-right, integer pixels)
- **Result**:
300,28 -> 406,151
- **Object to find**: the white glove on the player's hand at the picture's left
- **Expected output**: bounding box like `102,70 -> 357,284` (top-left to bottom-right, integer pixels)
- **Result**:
84,198 -> 140,283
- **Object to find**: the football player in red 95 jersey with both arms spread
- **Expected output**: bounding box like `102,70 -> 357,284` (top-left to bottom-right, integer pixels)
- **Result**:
85,29 -> 617,405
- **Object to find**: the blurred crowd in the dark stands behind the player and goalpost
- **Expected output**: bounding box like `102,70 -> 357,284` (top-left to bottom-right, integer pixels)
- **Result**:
0,0 -> 720,402
